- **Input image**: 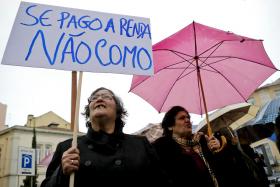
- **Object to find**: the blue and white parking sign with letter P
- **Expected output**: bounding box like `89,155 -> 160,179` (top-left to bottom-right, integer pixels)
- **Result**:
18,147 -> 36,176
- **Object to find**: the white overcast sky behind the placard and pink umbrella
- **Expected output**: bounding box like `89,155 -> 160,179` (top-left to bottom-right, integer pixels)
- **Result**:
0,0 -> 280,133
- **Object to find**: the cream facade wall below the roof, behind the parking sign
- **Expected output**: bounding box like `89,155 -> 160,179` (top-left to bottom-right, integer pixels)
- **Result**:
0,126 -> 83,187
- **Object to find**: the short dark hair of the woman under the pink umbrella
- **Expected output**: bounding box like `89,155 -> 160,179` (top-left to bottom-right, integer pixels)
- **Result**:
161,106 -> 189,136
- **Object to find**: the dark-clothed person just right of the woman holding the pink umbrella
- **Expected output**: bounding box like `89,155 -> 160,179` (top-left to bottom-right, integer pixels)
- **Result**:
215,127 -> 269,187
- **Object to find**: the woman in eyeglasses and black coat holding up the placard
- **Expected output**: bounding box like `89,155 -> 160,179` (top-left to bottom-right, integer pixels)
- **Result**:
41,87 -> 168,187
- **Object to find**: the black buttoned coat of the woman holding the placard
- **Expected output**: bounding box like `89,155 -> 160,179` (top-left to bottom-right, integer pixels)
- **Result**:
41,128 -> 165,187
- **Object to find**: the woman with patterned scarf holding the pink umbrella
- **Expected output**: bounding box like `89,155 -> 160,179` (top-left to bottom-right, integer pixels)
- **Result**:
152,106 -> 220,187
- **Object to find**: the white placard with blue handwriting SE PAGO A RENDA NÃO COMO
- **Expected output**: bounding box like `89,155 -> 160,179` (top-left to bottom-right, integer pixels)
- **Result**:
2,2 -> 154,75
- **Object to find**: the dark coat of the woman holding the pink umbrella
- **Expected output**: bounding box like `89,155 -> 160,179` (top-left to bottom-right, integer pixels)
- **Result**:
153,137 -> 219,187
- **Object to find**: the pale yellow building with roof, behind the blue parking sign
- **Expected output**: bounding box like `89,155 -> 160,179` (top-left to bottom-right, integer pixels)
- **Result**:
0,112 -> 82,187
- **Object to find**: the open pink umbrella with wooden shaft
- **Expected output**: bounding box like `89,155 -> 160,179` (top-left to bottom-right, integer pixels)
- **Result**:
130,22 -> 277,135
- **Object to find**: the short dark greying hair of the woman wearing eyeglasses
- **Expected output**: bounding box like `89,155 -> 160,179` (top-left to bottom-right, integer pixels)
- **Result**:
82,87 -> 127,132
